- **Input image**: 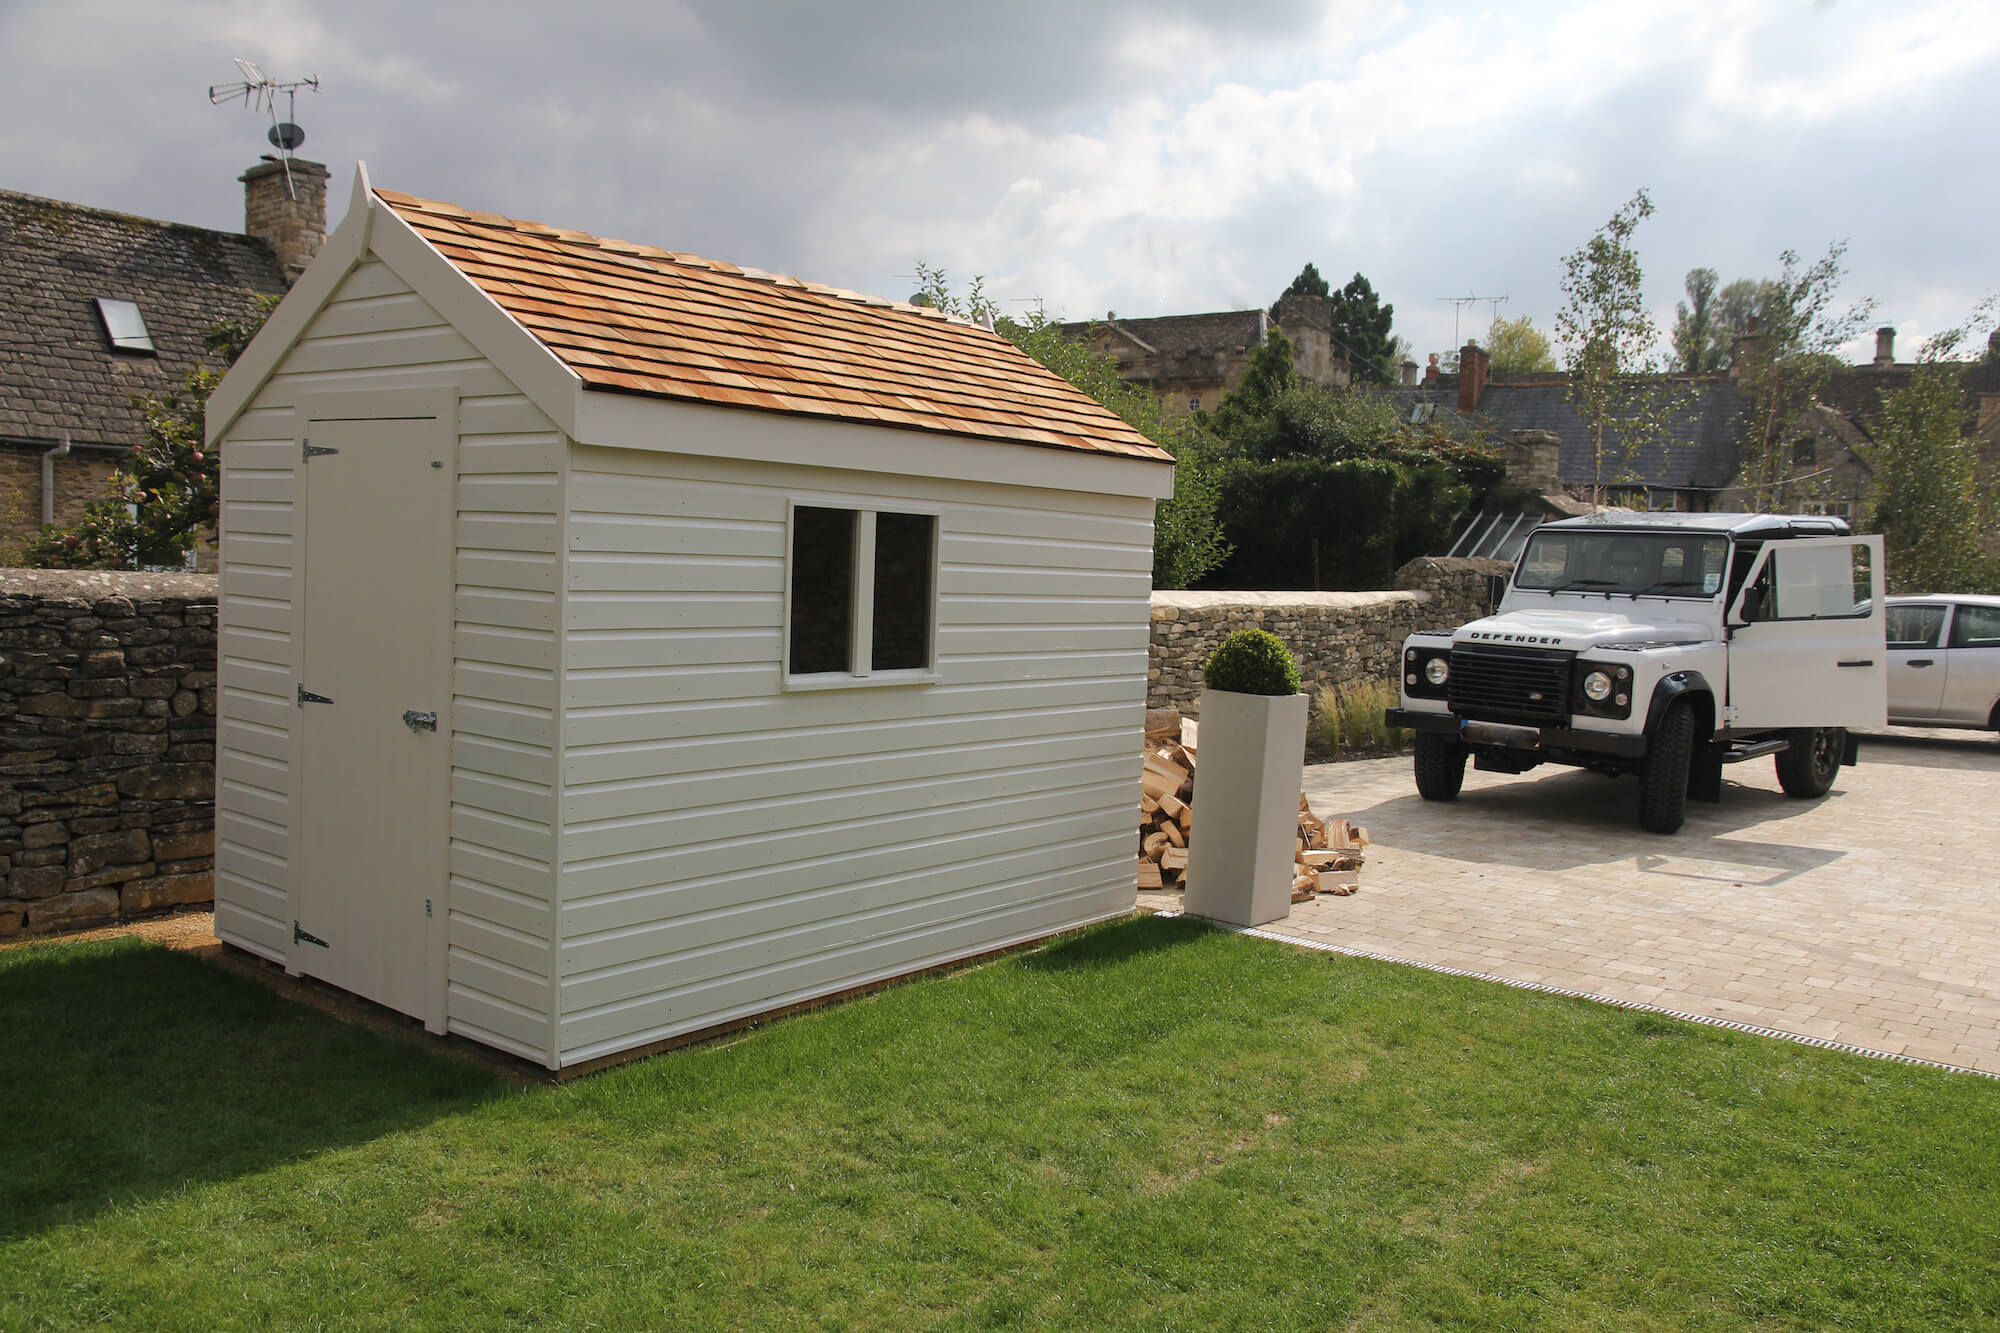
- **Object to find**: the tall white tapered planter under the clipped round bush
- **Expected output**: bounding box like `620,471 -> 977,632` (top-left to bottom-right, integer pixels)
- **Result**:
1186,691 -> 1306,927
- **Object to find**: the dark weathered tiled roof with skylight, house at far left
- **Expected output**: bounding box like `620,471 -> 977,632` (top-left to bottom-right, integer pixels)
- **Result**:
0,190 -> 284,446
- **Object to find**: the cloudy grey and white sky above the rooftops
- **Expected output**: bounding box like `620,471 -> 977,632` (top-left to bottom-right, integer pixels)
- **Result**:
0,0 -> 2000,356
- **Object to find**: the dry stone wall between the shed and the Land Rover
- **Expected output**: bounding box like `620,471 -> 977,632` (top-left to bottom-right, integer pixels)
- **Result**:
1146,556 -> 1512,715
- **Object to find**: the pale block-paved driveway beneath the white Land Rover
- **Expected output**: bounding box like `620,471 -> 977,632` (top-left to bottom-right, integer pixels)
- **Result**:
1232,731 -> 2000,1075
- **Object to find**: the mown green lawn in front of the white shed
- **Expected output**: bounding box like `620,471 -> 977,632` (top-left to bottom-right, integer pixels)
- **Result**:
0,919 -> 2000,1329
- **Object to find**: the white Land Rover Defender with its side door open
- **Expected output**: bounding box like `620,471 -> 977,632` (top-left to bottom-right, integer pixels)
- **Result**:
1388,514 -> 1888,833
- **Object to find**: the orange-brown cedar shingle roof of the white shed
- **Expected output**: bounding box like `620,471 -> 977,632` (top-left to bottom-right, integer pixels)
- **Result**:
376,190 -> 1168,460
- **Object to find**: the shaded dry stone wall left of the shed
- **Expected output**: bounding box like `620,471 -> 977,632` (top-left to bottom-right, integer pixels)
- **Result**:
0,570 -> 216,937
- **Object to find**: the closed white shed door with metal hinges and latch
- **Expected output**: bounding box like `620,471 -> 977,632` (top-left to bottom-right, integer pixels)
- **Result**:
292,418 -> 454,1025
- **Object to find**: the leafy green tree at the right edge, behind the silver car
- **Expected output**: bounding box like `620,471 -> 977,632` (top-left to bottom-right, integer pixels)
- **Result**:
1866,312 -> 2000,592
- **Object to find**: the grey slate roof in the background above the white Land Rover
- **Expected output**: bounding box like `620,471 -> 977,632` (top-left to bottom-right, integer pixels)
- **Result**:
1390,376 -> 1750,490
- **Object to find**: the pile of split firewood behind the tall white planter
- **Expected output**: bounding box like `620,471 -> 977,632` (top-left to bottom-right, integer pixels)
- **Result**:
1138,709 -> 1368,903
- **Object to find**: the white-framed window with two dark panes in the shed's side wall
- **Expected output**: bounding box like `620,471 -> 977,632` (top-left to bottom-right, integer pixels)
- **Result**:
784,504 -> 938,689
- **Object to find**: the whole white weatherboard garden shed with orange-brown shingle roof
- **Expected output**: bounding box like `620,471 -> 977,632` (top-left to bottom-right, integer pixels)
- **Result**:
208,168 -> 1172,1069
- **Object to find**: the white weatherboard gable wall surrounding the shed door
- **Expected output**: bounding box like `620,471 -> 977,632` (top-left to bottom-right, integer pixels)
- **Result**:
216,260 -> 564,1063
